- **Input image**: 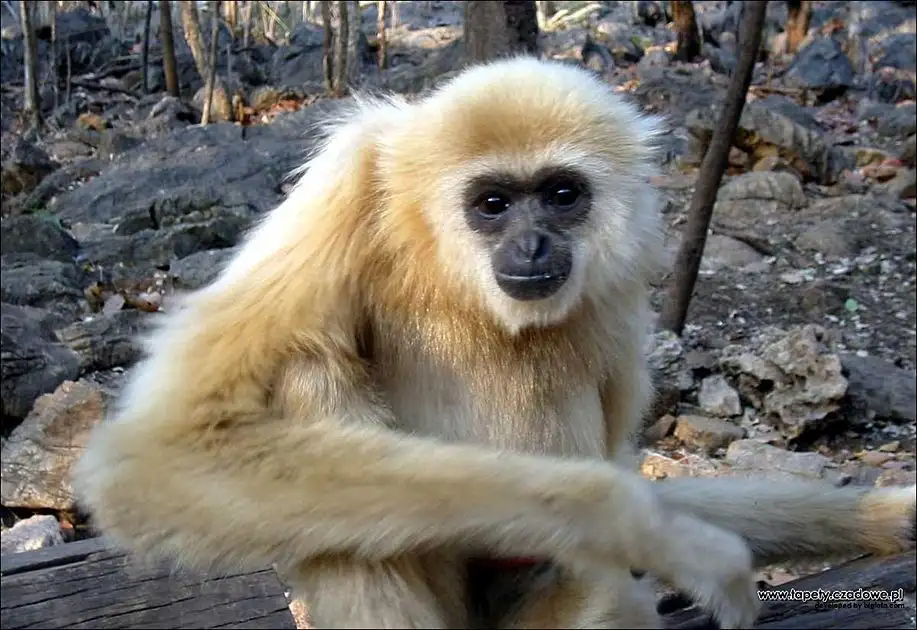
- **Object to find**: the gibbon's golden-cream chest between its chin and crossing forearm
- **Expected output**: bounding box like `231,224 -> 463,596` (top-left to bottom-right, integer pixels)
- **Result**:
370,318 -> 605,457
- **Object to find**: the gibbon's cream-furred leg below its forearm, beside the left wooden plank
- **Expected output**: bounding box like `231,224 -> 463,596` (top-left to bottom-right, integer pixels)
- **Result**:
285,555 -> 467,628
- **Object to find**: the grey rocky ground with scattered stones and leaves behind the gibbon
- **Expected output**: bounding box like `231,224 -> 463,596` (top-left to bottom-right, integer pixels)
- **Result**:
0,2 -> 917,624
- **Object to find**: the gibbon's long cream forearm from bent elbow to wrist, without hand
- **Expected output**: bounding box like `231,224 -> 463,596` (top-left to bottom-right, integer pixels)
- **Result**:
75,332 -> 724,584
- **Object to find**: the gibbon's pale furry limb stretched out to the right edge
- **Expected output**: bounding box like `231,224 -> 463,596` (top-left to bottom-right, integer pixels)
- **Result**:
656,477 -> 917,566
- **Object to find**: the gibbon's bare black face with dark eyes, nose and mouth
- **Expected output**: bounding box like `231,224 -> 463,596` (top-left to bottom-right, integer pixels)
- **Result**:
465,168 -> 591,300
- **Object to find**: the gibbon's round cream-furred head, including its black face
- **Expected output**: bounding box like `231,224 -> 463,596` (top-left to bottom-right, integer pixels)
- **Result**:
382,57 -> 661,331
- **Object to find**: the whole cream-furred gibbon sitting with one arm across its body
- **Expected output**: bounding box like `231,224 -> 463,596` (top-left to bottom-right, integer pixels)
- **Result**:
74,58 -> 915,628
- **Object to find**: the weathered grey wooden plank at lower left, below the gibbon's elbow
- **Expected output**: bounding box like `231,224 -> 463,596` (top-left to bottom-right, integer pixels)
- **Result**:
0,540 -> 296,630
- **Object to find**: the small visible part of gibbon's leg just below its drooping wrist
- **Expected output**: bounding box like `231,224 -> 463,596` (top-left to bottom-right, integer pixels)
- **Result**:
499,569 -> 662,630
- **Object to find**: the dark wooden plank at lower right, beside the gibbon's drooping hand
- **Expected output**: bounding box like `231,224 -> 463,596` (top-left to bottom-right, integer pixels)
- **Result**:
665,551 -> 917,630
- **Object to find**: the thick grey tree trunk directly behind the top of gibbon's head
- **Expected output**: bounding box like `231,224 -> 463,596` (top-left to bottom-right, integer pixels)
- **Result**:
465,0 -> 538,63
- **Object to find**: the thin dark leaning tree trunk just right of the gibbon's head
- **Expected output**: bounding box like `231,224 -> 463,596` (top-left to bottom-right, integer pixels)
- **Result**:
659,1 -> 767,336
